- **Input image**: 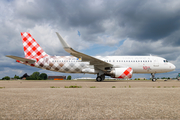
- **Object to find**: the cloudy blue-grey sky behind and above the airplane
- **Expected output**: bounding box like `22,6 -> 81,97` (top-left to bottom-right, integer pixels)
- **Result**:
0,0 -> 180,78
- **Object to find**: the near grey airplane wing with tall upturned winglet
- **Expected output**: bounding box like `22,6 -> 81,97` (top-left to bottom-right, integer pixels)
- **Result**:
56,32 -> 113,71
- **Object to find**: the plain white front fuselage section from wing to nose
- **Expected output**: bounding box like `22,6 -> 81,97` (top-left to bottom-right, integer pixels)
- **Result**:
95,56 -> 175,73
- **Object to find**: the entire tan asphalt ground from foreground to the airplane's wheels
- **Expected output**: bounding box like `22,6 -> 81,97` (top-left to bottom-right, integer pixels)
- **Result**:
0,81 -> 180,120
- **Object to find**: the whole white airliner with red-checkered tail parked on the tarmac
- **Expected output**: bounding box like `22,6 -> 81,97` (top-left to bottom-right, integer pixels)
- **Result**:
6,32 -> 176,82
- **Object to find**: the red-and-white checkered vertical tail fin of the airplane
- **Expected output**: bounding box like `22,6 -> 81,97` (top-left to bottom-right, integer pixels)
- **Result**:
21,32 -> 48,58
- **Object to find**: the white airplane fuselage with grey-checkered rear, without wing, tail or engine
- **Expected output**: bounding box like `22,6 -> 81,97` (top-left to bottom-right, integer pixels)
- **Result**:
30,56 -> 175,74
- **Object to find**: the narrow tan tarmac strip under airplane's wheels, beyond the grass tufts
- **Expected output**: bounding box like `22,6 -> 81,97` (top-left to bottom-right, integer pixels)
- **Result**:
0,80 -> 180,88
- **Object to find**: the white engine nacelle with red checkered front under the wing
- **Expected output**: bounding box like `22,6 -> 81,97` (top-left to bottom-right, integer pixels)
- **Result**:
111,67 -> 133,79
